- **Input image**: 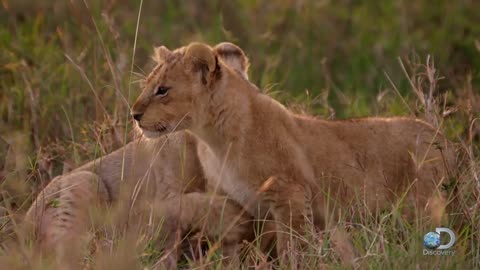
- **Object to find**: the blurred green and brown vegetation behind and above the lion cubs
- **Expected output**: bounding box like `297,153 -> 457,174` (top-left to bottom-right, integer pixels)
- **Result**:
0,0 -> 480,207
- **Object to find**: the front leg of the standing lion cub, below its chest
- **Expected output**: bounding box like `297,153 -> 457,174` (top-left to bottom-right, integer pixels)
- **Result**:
262,176 -> 313,256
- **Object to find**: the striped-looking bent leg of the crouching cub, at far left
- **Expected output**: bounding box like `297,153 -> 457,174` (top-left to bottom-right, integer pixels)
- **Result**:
25,171 -> 109,260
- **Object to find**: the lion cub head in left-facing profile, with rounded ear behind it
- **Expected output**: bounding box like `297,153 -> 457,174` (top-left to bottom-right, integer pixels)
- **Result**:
132,42 -> 249,138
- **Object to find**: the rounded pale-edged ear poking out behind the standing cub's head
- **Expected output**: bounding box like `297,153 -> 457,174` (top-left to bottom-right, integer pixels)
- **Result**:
213,42 -> 250,80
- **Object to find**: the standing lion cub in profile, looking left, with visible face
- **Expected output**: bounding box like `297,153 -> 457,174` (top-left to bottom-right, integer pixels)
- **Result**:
132,43 -> 455,252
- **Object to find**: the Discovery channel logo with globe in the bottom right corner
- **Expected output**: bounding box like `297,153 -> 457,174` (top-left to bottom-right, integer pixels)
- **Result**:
423,228 -> 457,256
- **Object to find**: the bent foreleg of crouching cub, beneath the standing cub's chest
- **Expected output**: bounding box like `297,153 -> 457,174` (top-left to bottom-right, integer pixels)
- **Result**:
154,192 -> 253,266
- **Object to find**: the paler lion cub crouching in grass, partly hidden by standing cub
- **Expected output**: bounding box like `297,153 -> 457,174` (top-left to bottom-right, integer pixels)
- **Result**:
25,43 -> 262,266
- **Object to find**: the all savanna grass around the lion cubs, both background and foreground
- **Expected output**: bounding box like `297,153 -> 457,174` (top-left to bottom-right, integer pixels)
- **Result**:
0,0 -> 480,269
